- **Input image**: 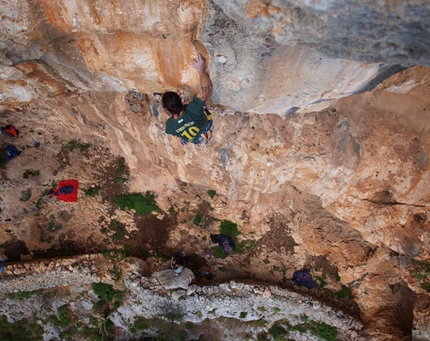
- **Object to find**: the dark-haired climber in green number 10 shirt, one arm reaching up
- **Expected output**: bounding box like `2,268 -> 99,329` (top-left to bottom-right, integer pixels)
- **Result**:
162,54 -> 212,146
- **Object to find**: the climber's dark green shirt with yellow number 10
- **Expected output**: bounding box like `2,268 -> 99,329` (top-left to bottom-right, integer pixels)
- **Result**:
166,96 -> 212,142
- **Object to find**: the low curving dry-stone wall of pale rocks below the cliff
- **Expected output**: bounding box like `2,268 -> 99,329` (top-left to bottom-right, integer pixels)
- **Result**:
0,254 -> 364,340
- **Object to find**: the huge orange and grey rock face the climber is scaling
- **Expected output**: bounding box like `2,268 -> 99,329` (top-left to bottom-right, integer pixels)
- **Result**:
0,0 -> 430,340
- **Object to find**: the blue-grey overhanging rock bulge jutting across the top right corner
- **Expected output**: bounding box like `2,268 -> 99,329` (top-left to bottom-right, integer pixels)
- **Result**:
214,0 -> 430,65
